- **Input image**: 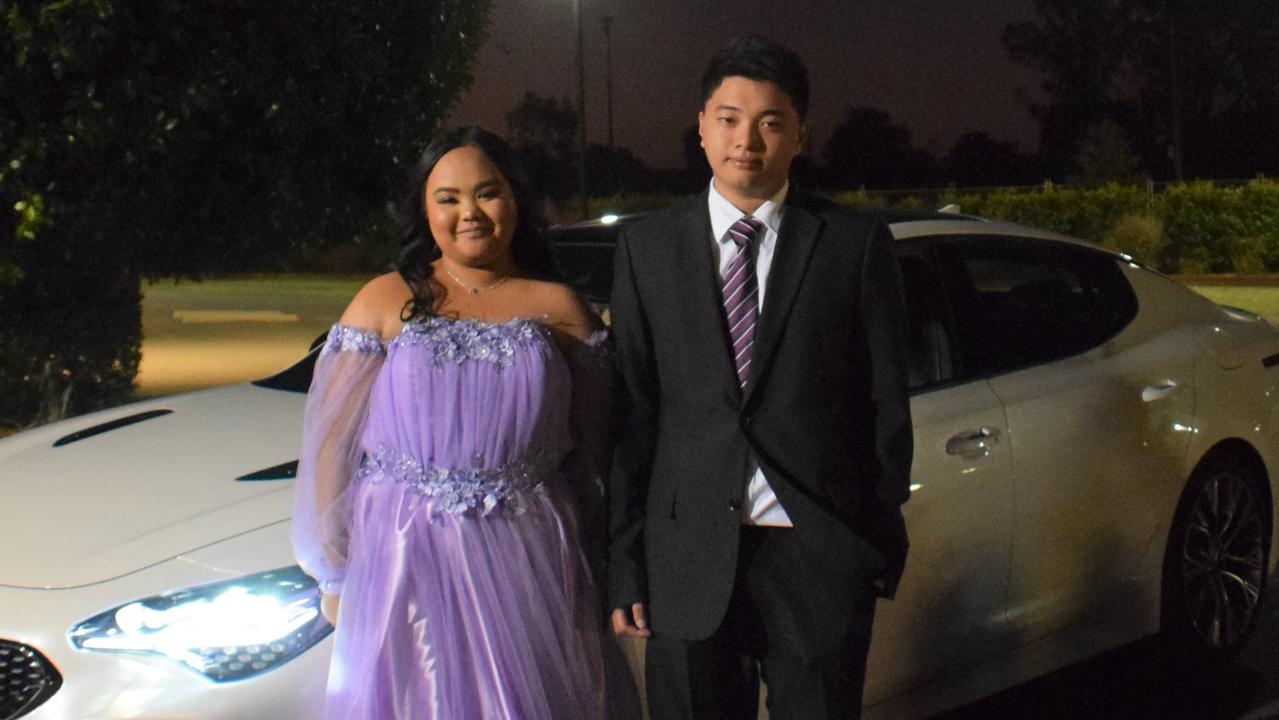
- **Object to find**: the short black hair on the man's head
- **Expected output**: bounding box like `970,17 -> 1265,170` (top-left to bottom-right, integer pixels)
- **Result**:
702,35 -> 808,121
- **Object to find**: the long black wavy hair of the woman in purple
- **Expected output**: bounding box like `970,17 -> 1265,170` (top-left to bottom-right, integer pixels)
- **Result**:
395,125 -> 556,321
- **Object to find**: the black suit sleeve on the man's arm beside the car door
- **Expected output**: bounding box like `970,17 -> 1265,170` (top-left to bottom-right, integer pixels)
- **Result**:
861,223 -> 914,597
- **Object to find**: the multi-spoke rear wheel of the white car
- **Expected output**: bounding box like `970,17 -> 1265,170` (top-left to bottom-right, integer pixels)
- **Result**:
1163,455 -> 1270,665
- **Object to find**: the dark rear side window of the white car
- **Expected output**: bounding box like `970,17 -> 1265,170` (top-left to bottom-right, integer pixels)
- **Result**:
938,238 -> 1137,376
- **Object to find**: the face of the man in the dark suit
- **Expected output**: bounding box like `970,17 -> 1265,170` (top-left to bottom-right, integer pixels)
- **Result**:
697,75 -> 807,212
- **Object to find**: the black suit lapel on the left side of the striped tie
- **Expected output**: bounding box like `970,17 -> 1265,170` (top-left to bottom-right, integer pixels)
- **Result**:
673,192 -> 741,395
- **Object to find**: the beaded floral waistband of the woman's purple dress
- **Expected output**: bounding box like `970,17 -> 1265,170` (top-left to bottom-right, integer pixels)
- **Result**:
357,445 -> 554,517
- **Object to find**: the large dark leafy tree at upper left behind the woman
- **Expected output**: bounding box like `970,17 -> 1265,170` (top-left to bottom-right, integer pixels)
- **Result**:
0,0 -> 487,425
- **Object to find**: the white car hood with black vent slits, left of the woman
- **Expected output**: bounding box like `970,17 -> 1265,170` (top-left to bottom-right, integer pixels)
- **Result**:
0,385 -> 306,588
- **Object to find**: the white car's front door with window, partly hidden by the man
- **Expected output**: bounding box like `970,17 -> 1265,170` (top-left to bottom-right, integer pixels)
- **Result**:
866,242 -> 1013,705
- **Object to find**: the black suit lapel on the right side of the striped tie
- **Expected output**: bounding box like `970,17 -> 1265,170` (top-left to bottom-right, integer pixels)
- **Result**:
743,196 -> 821,404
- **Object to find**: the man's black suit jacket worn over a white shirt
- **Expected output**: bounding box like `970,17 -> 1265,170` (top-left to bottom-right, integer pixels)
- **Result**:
609,189 -> 912,639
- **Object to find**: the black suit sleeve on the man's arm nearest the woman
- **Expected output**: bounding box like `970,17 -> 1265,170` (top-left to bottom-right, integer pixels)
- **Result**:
608,230 -> 659,607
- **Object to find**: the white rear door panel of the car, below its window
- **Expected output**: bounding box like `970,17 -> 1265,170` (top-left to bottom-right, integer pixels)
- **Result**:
991,323 -> 1195,641
